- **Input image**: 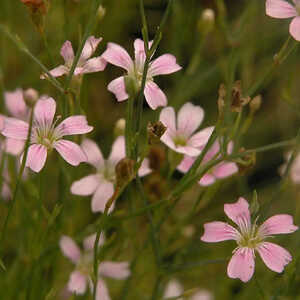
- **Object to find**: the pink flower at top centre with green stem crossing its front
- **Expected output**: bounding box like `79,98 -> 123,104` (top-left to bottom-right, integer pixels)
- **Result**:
102,39 -> 181,109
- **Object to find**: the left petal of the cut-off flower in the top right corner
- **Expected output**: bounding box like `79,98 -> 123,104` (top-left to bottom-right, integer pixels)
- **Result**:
266,0 -> 297,19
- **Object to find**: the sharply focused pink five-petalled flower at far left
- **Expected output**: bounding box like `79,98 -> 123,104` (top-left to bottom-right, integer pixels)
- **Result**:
2,98 -> 93,172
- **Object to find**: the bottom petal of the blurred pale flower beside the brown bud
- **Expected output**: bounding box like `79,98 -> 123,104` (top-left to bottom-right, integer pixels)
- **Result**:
92,181 -> 114,213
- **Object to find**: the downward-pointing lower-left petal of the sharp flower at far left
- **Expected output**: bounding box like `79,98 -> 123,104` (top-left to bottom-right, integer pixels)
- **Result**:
21,144 -> 47,173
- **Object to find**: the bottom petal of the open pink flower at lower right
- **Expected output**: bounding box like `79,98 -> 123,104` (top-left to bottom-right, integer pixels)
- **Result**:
227,248 -> 255,282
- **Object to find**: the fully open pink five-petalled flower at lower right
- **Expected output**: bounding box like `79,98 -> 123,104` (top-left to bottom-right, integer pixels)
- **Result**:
201,198 -> 298,282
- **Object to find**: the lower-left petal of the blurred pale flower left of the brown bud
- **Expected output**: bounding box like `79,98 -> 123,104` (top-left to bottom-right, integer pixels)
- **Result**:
71,174 -> 100,196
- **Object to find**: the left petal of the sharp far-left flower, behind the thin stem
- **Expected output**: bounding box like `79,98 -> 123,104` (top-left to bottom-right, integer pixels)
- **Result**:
1,118 -> 29,140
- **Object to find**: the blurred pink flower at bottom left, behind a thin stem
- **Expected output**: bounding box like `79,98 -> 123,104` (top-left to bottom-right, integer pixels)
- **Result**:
59,234 -> 130,300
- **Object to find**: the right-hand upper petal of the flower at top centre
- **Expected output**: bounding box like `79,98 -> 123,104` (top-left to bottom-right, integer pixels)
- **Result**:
149,54 -> 181,76
